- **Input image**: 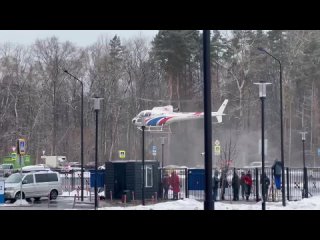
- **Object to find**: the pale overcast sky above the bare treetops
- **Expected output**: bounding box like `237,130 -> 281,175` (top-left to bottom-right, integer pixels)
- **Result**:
0,30 -> 158,47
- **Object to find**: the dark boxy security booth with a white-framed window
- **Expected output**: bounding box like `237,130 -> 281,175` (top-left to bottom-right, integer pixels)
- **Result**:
105,160 -> 159,202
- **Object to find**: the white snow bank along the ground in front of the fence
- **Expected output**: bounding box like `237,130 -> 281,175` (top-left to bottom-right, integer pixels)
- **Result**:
99,196 -> 320,210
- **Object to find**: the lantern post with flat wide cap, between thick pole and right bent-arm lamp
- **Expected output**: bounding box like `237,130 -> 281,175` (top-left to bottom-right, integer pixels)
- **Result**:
255,81 -> 271,210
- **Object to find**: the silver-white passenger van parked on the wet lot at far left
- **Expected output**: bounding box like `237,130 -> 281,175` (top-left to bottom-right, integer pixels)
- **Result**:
4,171 -> 62,201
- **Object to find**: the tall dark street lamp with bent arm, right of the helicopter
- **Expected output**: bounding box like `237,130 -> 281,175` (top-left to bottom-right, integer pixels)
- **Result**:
258,47 -> 286,207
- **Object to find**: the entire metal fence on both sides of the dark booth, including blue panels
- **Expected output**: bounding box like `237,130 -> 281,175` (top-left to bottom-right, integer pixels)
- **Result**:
60,167 -> 320,202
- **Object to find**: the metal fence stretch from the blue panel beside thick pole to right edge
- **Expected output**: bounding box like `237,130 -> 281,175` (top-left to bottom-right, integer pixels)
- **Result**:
187,167 -> 320,202
